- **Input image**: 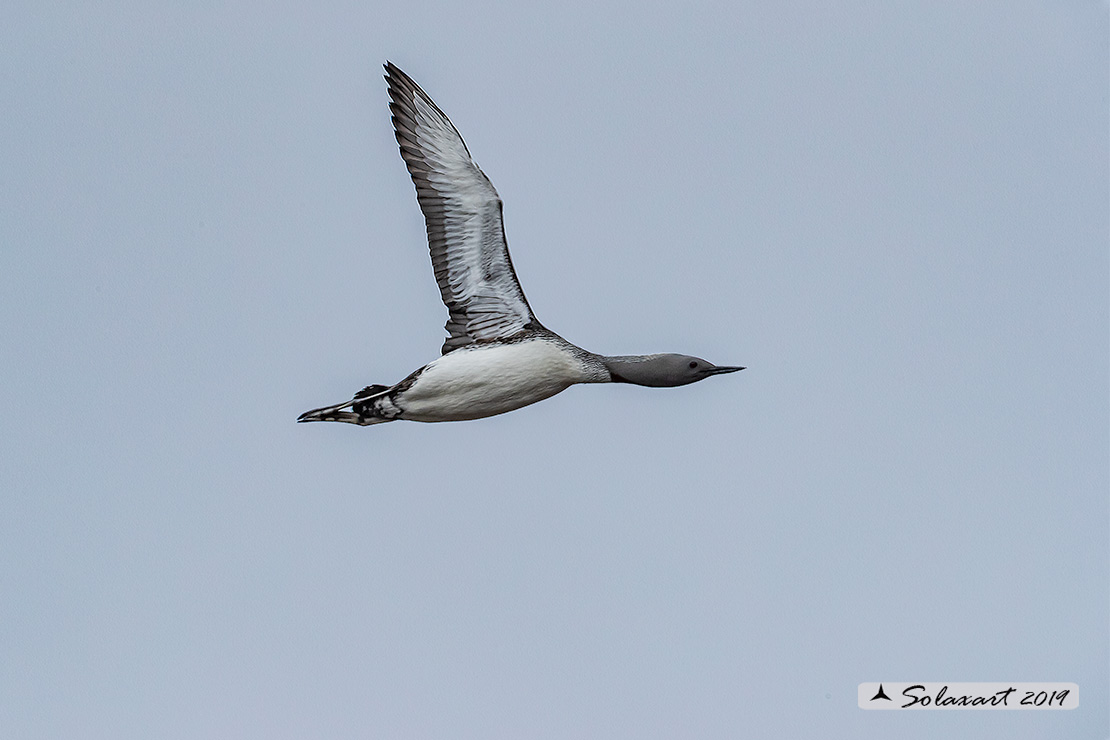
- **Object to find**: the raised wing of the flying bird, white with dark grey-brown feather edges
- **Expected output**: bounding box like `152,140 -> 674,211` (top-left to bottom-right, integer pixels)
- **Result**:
385,62 -> 538,354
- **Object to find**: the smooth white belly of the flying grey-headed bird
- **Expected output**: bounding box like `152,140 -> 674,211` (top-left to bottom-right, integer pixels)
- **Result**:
395,341 -> 587,422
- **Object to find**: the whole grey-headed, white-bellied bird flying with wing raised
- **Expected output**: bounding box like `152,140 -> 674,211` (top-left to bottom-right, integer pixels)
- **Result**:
296,62 -> 744,425
